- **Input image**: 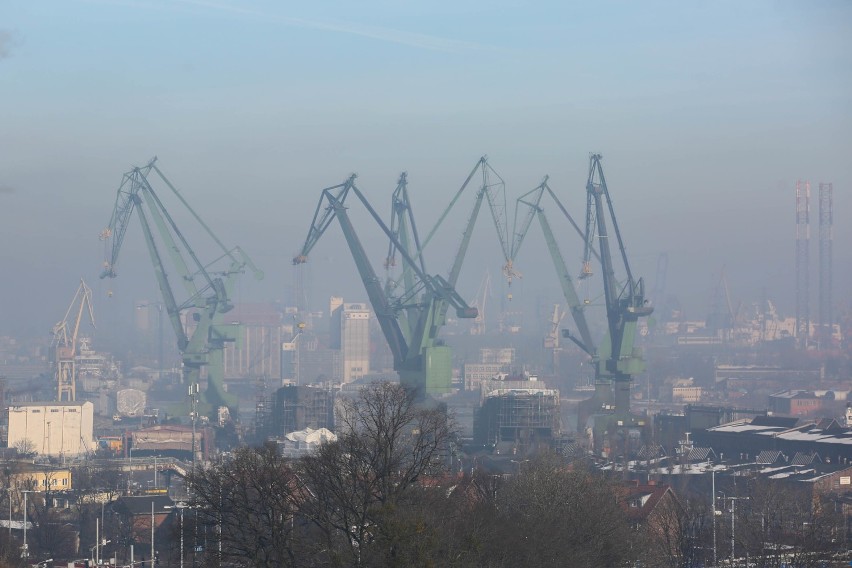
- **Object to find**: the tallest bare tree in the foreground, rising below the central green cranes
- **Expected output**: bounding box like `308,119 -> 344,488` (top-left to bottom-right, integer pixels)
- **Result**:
300,382 -> 460,566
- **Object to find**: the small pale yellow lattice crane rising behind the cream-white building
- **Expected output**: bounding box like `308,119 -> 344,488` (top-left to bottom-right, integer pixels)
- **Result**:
52,278 -> 95,402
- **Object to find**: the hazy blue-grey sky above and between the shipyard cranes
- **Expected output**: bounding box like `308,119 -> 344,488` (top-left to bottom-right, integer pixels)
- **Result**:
0,0 -> 852,342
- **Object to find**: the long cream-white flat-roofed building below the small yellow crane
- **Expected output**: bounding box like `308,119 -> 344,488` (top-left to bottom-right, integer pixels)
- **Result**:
9,401 -> 95,456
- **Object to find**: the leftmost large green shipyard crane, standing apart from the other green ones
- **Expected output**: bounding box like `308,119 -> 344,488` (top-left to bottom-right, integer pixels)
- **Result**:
100,157 -> 263,419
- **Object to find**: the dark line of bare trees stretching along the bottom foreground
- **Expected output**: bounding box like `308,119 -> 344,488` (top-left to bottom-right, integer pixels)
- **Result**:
0,383 -> 848,568
